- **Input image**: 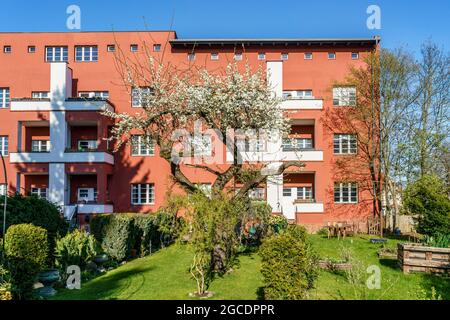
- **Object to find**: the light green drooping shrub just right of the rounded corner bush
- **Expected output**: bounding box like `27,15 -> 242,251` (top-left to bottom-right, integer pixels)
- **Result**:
55,229 -> 100,269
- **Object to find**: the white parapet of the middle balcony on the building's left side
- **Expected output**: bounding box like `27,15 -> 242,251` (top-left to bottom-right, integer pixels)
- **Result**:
9,151 -> 114,164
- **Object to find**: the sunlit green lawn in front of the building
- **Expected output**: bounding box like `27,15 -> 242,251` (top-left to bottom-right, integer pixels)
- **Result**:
51,235 -> 450,300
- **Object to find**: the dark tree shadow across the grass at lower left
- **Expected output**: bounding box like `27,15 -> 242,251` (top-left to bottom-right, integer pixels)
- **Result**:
55,266 -> 153,300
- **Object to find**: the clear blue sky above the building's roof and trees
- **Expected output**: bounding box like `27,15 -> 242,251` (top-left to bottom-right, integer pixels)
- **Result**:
0,0 -> 450,53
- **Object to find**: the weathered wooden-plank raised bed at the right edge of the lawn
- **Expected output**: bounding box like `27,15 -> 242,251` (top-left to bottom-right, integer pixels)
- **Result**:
398,243 -> 450,273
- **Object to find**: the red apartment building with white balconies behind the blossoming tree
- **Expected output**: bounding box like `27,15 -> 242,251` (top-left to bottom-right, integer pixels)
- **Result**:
0,31 -> 377,228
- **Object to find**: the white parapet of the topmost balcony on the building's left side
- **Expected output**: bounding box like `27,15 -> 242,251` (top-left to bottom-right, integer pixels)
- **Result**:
11,98 -> 114,111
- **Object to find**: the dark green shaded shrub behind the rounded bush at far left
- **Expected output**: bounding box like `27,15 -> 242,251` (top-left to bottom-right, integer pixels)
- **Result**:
0,195 -> 68,265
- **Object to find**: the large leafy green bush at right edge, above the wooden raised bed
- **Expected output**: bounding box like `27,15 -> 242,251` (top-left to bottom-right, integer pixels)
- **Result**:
403,175 -> 450,236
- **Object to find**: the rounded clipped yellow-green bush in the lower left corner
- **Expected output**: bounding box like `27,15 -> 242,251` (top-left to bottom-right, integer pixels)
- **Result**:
5,224 -> 48,300
